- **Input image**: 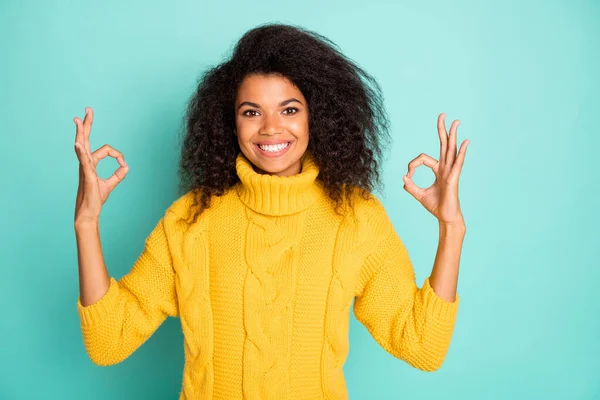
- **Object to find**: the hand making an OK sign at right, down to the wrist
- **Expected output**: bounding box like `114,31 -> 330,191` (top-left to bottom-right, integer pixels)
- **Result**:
402,113 -> 470,225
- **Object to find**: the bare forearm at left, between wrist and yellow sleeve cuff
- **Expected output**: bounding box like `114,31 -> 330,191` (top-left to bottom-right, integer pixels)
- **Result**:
75,220 -> 110,307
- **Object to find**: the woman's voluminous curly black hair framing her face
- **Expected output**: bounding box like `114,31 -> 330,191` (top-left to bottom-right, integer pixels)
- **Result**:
178,23 -> 390,225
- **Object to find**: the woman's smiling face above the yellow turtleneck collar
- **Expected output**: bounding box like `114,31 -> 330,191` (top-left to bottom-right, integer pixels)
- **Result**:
235,74 -> 308,176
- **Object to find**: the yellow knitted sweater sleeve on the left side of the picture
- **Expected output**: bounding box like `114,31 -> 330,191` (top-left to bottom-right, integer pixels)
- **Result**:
77,211 -> 179,366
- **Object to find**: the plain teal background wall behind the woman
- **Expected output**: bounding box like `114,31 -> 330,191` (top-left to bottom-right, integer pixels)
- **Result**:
0,0 -> 600,400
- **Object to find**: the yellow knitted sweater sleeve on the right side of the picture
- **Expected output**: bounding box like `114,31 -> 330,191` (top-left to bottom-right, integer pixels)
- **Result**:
354,206 -> 460,371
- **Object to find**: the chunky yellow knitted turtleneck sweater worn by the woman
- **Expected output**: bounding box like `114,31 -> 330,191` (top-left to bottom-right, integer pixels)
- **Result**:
77,152 -> 459,400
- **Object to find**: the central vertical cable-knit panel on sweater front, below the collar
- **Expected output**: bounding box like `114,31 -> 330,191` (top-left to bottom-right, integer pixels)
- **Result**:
244,210 -> 304,400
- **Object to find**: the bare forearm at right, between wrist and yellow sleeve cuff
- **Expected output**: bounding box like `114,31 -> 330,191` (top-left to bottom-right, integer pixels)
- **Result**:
429,223 -> 466,302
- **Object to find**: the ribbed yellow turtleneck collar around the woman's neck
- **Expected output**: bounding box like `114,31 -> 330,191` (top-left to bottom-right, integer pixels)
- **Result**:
235,150 -> 321,215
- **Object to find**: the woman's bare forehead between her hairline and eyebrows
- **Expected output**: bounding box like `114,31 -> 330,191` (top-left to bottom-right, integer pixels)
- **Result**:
236,74 -> 304,104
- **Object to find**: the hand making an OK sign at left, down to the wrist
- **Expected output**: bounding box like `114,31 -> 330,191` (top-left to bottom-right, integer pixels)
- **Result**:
73,107 -> 129,222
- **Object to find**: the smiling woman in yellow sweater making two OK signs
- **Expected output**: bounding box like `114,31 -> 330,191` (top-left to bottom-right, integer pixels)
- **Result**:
75,24 -> 468,400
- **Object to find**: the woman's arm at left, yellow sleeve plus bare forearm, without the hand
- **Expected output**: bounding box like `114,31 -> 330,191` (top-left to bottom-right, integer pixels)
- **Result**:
75,219 -> 179,365
